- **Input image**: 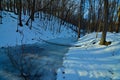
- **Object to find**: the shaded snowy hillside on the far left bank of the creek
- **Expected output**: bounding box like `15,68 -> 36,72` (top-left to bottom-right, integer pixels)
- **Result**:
0,11 -> 76,47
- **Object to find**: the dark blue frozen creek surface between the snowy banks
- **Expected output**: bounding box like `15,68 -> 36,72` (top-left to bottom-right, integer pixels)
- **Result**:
0,40 -> 73,80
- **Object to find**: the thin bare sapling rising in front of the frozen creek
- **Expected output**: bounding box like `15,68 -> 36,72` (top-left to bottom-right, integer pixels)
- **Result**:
6,31 -> 41,80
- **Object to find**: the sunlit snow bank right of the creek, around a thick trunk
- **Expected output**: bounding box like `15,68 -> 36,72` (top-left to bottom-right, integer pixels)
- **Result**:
57,33 -> 120,80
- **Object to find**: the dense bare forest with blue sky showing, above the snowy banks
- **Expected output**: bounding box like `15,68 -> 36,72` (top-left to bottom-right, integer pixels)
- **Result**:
0,0 -> 120,37
